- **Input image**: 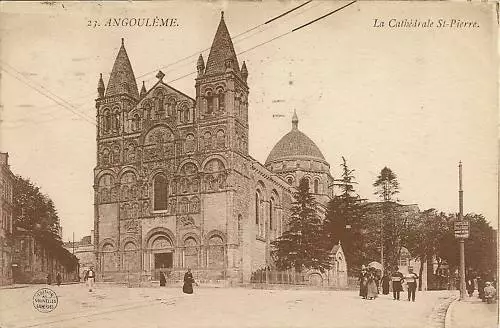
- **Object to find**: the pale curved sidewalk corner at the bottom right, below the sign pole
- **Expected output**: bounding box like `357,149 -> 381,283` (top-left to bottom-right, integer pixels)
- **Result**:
445,294 -> 498,328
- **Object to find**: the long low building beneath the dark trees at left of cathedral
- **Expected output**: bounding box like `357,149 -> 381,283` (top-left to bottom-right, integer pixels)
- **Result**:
12,227 -> 78,284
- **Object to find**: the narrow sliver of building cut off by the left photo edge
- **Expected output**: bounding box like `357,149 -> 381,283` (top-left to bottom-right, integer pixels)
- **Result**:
0,153 -> 15,286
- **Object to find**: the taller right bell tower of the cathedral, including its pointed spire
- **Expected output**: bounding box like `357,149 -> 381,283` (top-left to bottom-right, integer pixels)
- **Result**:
195,12 -> 248,156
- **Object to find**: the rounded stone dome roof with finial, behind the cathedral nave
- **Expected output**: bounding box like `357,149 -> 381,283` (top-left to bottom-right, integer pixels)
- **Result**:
266,113 -> 327,165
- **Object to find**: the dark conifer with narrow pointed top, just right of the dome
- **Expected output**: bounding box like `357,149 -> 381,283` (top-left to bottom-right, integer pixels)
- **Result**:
323,157 -> 365,275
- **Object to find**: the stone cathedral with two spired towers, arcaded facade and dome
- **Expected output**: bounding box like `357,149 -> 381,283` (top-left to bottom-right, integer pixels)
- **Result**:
94,14 -> 333,283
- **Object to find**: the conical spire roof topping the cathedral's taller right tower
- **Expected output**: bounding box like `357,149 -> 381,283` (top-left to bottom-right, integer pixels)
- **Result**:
205,12 -> 240,75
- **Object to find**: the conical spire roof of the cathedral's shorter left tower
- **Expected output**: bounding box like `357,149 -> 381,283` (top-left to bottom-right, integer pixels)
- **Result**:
106,38 -> 139,99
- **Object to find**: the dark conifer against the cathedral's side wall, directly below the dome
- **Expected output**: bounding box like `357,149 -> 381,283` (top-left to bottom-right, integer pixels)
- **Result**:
272,179 -> 331,272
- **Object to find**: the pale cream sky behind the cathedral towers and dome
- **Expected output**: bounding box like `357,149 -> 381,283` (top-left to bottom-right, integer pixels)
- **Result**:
0,1 -> 498,241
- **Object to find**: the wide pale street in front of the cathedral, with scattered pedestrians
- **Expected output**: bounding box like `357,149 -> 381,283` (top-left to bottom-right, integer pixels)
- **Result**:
0,284 -> 456,328
